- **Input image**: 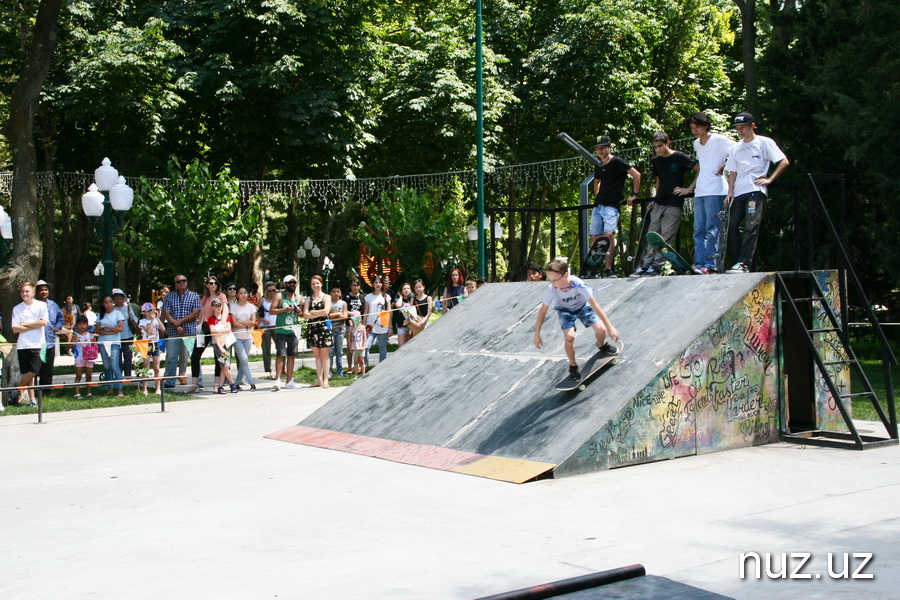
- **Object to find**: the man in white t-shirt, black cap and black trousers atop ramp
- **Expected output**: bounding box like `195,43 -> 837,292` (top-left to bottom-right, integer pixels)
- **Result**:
725,113 -> 791,273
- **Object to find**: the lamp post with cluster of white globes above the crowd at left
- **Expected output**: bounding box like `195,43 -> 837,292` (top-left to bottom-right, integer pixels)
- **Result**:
81,158 -> 134,294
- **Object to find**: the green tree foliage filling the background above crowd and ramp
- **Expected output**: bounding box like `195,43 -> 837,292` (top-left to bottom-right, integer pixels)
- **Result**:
0,0 -> 900,314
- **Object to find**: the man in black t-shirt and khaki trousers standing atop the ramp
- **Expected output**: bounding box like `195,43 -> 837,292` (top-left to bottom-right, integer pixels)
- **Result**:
628,131 -> 700,277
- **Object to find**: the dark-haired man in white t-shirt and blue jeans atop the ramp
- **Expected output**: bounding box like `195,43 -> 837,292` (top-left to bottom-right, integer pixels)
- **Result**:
688,112 -> 734,274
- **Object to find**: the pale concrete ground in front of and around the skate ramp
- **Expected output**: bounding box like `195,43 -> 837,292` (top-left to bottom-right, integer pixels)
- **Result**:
0,350 -> 900,600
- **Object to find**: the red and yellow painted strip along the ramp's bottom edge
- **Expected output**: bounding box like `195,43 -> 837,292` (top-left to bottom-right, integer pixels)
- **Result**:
264,425 -> 556,483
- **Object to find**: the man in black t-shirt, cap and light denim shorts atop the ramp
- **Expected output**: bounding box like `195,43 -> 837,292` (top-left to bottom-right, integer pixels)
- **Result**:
591,135 -> 641,277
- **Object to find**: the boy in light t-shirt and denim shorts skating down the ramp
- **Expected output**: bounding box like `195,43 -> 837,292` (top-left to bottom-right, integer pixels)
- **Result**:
534,258 -> 619,382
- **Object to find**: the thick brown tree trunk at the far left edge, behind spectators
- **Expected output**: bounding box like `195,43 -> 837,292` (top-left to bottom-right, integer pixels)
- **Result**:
0,0 -> 62,404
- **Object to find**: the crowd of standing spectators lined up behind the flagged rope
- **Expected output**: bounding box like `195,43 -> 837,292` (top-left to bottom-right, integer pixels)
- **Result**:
1,268 -> 492,402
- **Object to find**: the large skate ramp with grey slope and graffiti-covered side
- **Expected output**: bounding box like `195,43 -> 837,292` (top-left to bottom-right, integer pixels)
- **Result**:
267,273 -> 779,482
